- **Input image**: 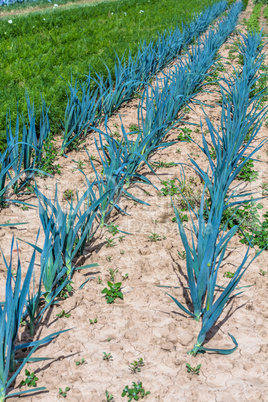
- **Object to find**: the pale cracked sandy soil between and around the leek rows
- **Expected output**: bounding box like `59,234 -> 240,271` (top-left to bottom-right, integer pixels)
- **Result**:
0,1 -> 268,402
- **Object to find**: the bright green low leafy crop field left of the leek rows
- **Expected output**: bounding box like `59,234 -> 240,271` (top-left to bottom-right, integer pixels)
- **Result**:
0,0 -> 218,152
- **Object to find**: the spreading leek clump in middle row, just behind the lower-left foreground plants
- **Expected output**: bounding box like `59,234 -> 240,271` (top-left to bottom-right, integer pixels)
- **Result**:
86,119 -> 162,221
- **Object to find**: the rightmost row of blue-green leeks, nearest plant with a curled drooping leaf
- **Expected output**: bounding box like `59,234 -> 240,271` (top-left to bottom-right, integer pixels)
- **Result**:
171,29 -> 267,354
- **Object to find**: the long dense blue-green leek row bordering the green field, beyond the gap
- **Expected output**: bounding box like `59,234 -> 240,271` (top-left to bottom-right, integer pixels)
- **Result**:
61,0 -> 227,153
